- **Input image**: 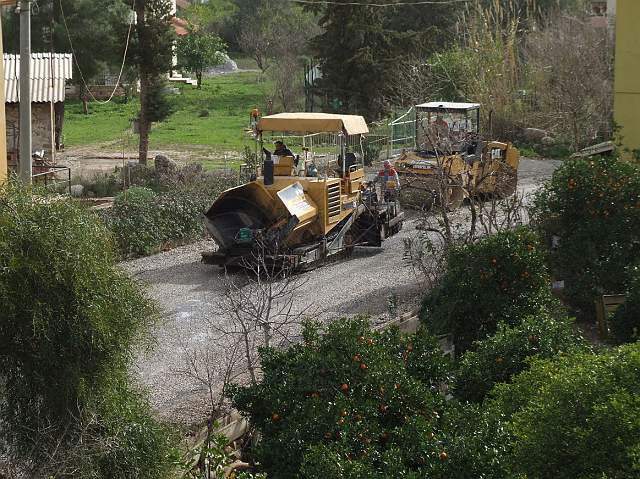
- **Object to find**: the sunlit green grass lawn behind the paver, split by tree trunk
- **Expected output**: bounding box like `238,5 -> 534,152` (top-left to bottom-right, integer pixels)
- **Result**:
64,72 -> 269,151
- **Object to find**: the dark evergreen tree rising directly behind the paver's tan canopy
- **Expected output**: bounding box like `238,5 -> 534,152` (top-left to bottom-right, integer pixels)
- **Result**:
309,0 -> 456,119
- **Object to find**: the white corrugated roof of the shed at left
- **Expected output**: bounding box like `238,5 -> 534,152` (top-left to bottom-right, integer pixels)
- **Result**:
2,53 -> 73,103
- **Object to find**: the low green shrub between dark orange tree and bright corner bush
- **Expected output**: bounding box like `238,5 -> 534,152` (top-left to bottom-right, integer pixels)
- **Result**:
455,313 -> 583,402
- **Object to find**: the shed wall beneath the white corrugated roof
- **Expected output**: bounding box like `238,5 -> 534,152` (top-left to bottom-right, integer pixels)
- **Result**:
5,103 -> 53,159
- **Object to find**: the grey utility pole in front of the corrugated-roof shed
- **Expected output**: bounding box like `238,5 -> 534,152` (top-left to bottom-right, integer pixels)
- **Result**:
20,0 -> 32,184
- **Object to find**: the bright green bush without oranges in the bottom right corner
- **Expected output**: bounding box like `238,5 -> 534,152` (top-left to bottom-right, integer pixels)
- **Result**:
485,344 -> 640,479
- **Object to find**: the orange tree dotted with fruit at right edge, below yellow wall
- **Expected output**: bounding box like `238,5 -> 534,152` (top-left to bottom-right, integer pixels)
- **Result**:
532,158 -> 640,317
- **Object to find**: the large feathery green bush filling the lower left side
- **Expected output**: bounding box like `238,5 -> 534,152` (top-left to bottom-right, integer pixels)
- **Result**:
0,184 -> 174,478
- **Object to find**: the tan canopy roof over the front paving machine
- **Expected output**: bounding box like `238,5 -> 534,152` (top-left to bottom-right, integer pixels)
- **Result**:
258,113 -> 369,135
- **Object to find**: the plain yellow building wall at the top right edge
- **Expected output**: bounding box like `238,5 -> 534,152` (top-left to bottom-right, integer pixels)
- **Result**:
614,0 -> 640,157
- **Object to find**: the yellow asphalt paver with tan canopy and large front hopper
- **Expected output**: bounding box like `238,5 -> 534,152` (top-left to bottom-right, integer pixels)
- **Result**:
203,113 -> 403,269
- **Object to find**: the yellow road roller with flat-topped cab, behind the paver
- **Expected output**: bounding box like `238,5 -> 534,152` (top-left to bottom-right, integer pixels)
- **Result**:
394,102 -> 520,210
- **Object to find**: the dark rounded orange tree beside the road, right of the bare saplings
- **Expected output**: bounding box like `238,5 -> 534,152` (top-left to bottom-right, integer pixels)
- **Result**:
420,228 -> 553,353
